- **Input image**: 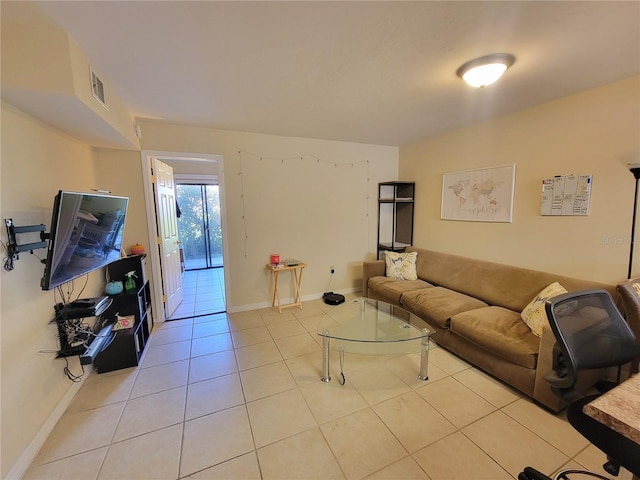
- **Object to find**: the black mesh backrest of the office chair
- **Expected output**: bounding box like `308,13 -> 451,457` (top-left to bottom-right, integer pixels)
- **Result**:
545,290 -> 640,390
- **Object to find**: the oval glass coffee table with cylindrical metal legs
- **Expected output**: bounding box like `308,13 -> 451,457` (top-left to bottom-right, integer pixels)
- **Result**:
318,298 -> 435,383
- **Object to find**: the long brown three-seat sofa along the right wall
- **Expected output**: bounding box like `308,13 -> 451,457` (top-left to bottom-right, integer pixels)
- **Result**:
363,247 -> 618,411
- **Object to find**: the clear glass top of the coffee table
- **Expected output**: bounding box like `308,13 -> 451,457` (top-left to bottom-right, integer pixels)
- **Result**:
318,298 -> 434,353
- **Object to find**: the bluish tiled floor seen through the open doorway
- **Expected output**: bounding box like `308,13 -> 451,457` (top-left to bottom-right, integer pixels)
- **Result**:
170,268 -> 227,319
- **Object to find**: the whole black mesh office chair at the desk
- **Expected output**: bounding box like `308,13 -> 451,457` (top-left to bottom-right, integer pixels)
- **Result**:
518,290 -> 640,480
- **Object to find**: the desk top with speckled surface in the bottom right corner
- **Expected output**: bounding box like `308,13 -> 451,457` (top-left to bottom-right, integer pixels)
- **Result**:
584,374 -> 640,444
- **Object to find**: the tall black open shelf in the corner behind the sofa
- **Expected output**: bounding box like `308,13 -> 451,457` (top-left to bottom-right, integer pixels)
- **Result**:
378,182 -> 416,259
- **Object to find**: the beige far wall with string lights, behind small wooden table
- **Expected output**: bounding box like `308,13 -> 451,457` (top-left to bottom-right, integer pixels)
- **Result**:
139,121 -> 398,311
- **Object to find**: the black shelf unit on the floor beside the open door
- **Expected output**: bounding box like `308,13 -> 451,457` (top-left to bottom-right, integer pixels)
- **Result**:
93,255 -> 153,373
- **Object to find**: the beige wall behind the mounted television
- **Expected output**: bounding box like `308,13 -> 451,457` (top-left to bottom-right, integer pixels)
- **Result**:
0,102 -> 103,478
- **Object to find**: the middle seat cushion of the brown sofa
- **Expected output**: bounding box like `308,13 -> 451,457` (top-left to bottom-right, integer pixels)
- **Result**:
400,287 -> 487,328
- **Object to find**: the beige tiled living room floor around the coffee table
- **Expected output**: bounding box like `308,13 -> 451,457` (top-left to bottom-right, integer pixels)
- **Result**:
25,294 -> 604,480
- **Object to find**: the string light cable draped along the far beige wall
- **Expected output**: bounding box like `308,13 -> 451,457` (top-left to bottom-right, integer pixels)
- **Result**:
238,150 -> 371,258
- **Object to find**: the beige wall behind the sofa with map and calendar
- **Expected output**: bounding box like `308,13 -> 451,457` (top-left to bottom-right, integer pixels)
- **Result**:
399,77 -> 640,283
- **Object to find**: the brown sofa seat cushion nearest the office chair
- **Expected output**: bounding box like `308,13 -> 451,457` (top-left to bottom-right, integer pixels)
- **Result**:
450,306 -> 540,368
